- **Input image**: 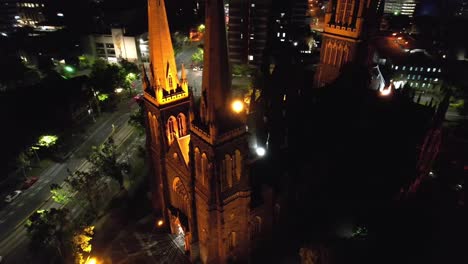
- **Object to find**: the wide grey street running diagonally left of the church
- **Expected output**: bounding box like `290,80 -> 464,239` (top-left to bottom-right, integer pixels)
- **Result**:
0,96 -> 138,259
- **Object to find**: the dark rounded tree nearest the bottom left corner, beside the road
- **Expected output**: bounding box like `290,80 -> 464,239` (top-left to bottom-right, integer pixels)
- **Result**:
25,208 -> 73,259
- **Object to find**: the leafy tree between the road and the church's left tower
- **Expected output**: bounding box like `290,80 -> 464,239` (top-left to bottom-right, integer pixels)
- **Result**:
88,137 -> 130,189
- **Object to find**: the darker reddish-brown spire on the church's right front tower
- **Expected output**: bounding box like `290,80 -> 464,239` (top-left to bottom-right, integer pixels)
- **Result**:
200,0 -> 231,126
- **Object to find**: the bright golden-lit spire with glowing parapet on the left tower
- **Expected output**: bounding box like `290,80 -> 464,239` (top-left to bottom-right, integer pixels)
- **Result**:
148,0 -> 188,105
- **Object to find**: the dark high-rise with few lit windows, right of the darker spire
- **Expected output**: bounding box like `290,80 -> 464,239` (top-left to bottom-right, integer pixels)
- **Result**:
225,0 -> 271,66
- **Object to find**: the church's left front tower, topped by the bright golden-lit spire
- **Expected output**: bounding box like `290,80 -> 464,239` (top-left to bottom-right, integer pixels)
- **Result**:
143,0 -> 190,220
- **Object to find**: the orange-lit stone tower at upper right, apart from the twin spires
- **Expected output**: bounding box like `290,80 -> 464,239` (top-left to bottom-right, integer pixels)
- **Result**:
315,0 -> 380,87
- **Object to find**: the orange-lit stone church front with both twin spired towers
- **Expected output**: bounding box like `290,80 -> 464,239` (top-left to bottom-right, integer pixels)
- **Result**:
144,0 -> 279,263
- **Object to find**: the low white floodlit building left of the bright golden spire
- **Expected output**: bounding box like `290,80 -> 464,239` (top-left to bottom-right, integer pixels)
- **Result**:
83,28 -> 144,63
